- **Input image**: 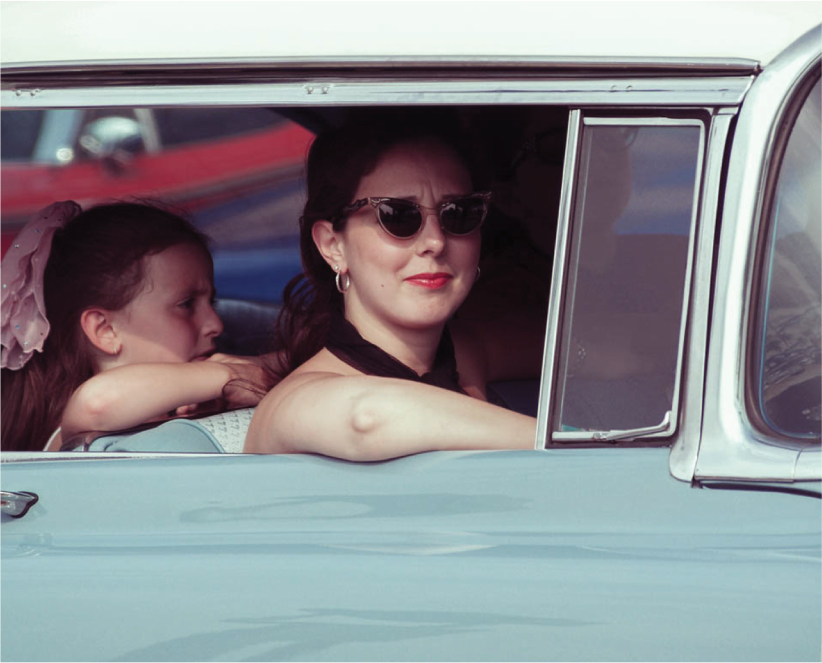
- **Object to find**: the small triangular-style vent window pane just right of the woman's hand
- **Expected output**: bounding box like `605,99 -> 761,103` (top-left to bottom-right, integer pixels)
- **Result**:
553,118 -> 704,440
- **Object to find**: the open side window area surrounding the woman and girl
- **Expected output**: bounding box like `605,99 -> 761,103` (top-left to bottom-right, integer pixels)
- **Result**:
0,106 -> 568,452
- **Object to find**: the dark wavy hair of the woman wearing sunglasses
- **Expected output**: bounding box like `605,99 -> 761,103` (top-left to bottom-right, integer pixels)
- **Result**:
274,109 -> 477,378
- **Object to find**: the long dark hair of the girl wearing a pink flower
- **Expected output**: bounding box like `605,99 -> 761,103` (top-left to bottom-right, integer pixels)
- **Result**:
0,203 -> 208,451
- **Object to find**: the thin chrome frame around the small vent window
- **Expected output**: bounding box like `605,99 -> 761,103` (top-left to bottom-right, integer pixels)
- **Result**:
548,115 -> 707,445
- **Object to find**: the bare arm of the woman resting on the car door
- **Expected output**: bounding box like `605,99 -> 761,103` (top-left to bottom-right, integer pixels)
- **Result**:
244,372 -> 536,461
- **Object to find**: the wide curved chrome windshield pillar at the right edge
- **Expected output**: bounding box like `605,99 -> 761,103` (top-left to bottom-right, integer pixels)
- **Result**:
693,26 -> 822,482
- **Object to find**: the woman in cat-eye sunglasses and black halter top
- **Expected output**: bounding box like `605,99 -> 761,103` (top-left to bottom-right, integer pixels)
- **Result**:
245,114 -> 539,460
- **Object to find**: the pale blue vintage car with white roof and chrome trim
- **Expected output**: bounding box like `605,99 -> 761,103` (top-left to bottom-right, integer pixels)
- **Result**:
0,0 -> 822,663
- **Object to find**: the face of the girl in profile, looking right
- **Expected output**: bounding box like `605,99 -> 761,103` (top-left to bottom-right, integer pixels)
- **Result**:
106,244 -> 223,366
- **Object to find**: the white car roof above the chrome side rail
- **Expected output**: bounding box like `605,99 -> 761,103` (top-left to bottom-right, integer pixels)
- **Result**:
0,0 -> 822,68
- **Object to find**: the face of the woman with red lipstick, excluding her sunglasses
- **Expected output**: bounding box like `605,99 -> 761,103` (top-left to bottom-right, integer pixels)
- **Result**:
339,141 -> 480,338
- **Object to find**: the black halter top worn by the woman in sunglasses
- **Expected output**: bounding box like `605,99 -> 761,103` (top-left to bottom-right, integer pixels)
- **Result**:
325,313 -> 465,394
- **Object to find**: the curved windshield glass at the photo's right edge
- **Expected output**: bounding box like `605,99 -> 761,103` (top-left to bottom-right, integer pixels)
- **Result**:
752,72 -> 822,439
